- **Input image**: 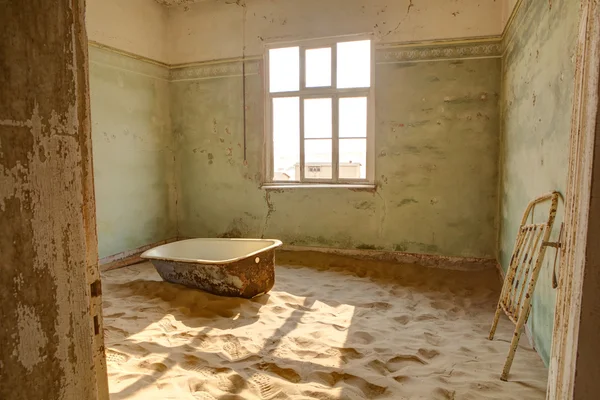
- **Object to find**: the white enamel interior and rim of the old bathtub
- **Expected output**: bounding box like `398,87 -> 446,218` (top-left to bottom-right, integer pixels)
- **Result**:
142,239 -> 281,264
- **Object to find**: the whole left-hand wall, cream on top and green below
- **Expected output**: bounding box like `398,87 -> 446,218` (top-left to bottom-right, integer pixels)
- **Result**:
86,0 -> 177,258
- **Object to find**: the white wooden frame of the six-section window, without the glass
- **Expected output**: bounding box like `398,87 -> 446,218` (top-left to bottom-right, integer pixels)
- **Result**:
263,34 -> 375,186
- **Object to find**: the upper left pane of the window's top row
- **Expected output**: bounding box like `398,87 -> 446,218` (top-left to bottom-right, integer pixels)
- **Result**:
269,47 -> 300,93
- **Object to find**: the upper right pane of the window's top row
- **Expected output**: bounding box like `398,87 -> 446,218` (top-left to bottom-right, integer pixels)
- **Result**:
337,40 -> 371,89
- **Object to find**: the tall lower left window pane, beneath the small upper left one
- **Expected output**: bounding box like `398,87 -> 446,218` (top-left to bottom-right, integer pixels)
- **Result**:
273,97 -> 300,181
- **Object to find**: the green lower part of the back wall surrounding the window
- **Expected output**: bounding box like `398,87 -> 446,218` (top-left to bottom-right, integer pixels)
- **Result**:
171,50 -> 500,257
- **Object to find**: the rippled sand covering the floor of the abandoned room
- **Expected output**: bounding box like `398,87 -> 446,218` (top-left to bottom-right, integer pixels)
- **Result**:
103,254 -> 547,400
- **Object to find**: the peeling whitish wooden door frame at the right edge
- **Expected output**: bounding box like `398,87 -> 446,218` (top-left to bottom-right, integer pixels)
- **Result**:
546,0 -> 600,400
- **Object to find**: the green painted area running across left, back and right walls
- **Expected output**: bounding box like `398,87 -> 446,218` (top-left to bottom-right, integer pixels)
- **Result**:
90,0 -> 578,362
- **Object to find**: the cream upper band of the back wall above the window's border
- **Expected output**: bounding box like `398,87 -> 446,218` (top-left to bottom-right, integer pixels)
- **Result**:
167,0 -> 503,64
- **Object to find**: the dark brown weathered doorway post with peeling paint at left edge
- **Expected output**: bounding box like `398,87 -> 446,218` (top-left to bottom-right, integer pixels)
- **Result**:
0,0 -> 105,400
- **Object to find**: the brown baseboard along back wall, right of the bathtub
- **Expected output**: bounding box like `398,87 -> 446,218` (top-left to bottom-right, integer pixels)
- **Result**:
281,245 -> 497,271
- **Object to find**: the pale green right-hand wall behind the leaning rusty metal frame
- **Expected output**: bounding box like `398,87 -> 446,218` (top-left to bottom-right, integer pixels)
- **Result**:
499,0 -> 579,364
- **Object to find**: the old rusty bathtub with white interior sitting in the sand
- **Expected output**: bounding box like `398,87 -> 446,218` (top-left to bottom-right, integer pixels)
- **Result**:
141,239 -> 281,298
